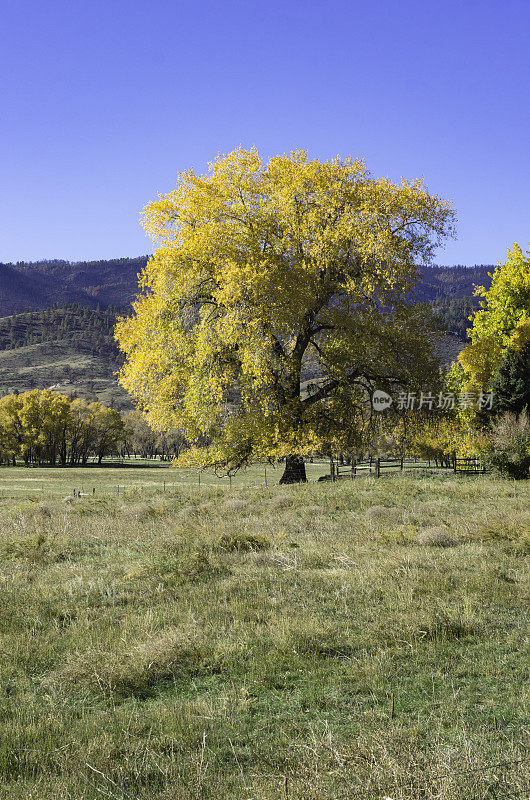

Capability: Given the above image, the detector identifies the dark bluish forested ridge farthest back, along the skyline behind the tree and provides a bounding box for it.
[0,256,494,316]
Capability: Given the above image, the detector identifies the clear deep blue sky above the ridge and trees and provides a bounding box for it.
[0,0,530,264]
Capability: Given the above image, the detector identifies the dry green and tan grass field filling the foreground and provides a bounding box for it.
[0,470,530,800]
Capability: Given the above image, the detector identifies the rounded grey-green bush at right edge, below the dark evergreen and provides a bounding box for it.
[484,412,530,478]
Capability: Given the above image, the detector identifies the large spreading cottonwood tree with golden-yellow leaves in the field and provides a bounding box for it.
[116,149,454,480]
